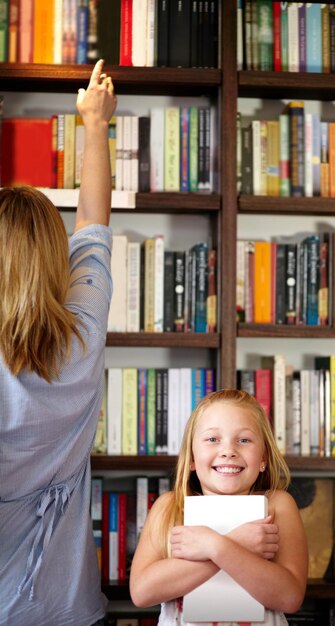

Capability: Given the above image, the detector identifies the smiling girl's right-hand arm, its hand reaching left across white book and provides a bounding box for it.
[172,491,308,613]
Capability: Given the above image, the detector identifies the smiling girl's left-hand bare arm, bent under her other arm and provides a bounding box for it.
[130,492,219,607]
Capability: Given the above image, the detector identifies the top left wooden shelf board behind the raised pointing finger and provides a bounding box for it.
[0,63,222,95]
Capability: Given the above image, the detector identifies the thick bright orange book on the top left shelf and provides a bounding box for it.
[33,0,54,63]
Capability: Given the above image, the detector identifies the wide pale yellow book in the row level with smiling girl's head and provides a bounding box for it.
[122,367,138,455]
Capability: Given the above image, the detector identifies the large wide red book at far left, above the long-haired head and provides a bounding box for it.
[1,118,52,187]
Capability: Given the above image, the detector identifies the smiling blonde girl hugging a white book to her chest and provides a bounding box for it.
[130,389,308,626]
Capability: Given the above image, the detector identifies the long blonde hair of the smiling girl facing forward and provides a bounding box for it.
[160,389,290,556]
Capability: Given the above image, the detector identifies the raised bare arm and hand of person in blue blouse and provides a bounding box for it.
[75,59,116,230]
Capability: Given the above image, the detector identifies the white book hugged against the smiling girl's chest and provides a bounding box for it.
[183,495,268,622]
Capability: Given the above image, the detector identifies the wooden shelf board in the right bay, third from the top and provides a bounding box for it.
[237,323,335,339]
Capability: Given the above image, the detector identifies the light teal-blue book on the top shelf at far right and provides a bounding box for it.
[306,2,322,72]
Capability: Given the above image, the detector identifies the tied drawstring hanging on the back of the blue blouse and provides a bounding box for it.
[18,483,70,600]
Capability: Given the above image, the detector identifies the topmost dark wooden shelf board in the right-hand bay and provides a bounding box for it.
[237,70,334,100]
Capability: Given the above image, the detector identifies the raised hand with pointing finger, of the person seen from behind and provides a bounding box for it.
[77,59,117,124]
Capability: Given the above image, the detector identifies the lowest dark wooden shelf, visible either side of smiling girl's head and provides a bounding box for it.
[91,454,335,472]
